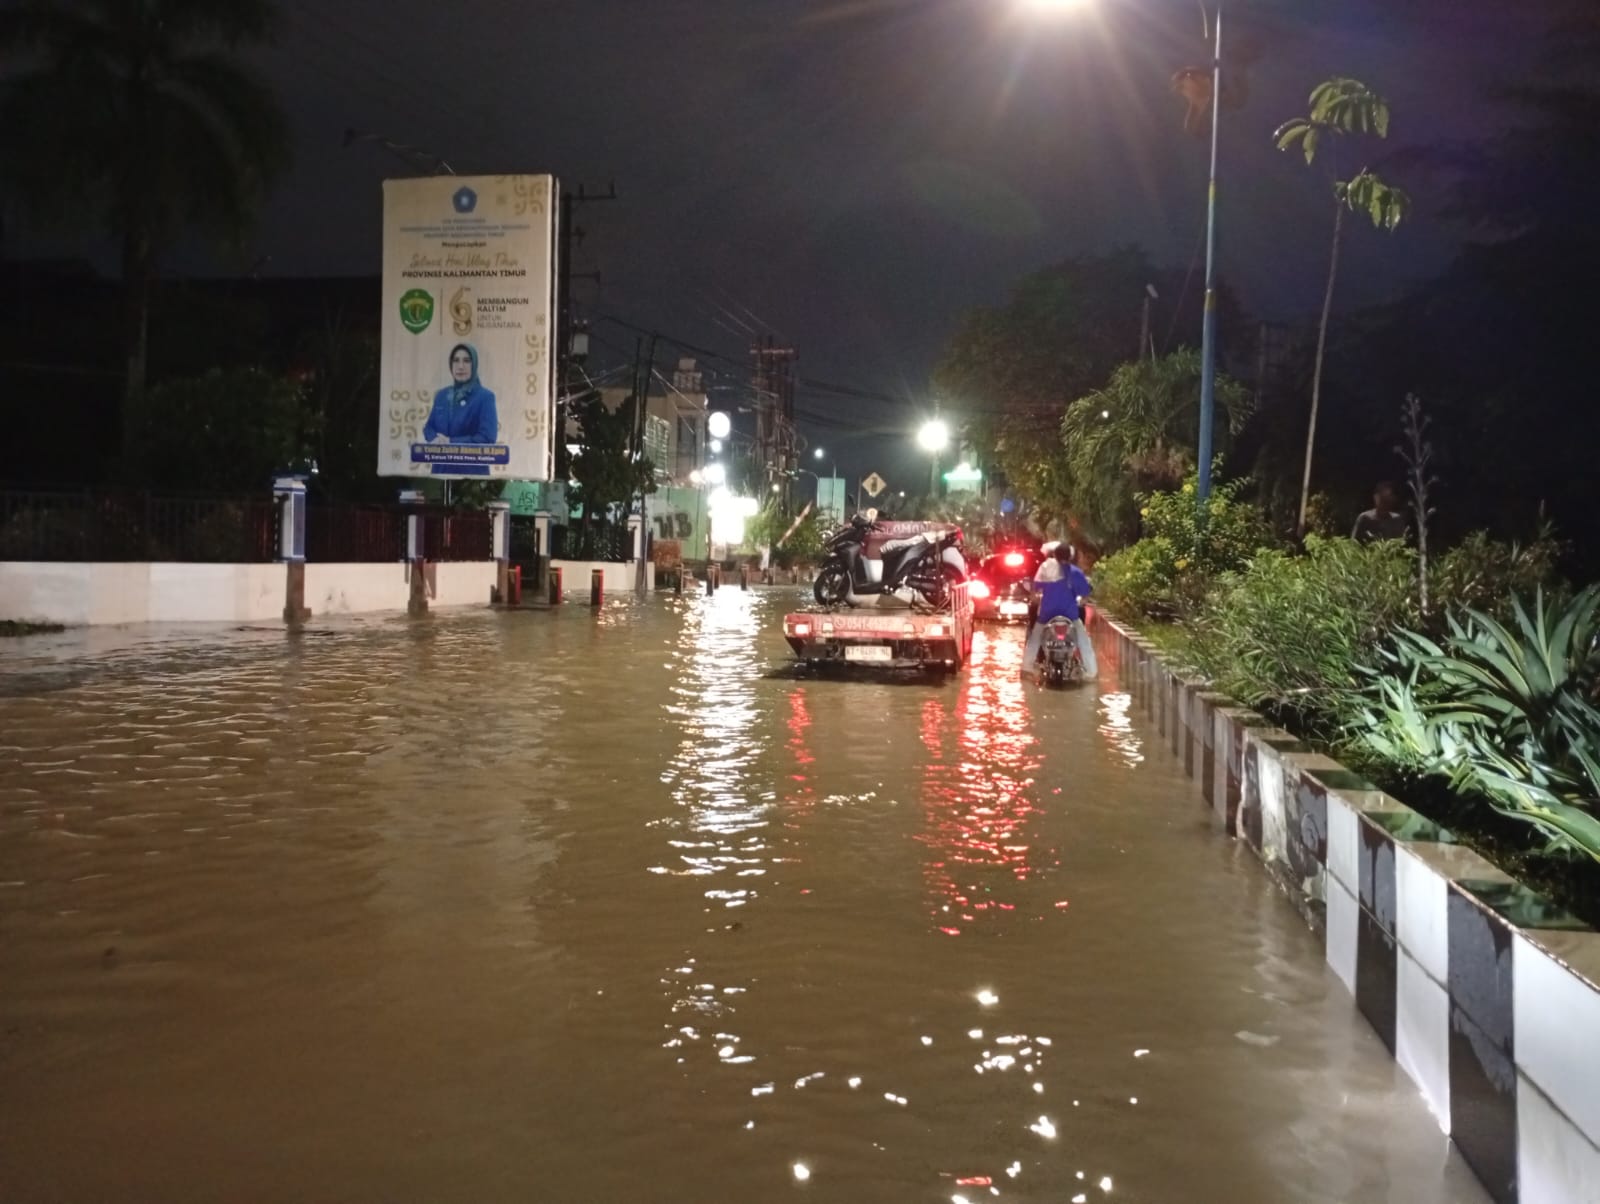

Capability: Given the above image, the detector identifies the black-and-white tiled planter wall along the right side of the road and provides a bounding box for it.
[1094,615,1600,1204]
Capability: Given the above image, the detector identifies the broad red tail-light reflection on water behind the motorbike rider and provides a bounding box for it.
[918,631,1040,937]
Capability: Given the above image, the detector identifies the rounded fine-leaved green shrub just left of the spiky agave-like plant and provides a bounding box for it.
[1194,535,1418,740]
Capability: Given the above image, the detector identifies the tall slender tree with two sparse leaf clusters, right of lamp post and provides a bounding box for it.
[1272,77,1411,535]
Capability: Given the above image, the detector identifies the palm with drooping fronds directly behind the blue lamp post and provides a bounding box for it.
[1061,347,1253,544]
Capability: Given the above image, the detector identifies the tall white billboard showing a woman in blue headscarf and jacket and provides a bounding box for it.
[378,176,557,480]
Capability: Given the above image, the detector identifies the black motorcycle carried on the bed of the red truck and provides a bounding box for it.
[811,511,966,610]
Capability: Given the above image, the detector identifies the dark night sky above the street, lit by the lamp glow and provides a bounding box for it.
[190,0,1541,480]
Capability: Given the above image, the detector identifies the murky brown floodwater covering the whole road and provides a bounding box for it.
[0,589,1482,1204]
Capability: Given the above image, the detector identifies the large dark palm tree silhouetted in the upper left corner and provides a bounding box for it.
[0,0,290,447]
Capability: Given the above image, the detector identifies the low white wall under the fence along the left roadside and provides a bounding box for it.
[0,560,499,628]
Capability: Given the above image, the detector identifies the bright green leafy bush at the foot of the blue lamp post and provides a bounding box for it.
[1094,477,1270,620]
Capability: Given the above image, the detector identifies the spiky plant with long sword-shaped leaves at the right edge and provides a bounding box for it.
[1350,586,1600,861]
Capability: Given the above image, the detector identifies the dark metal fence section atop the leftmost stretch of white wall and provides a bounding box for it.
[0,490,278,564]
